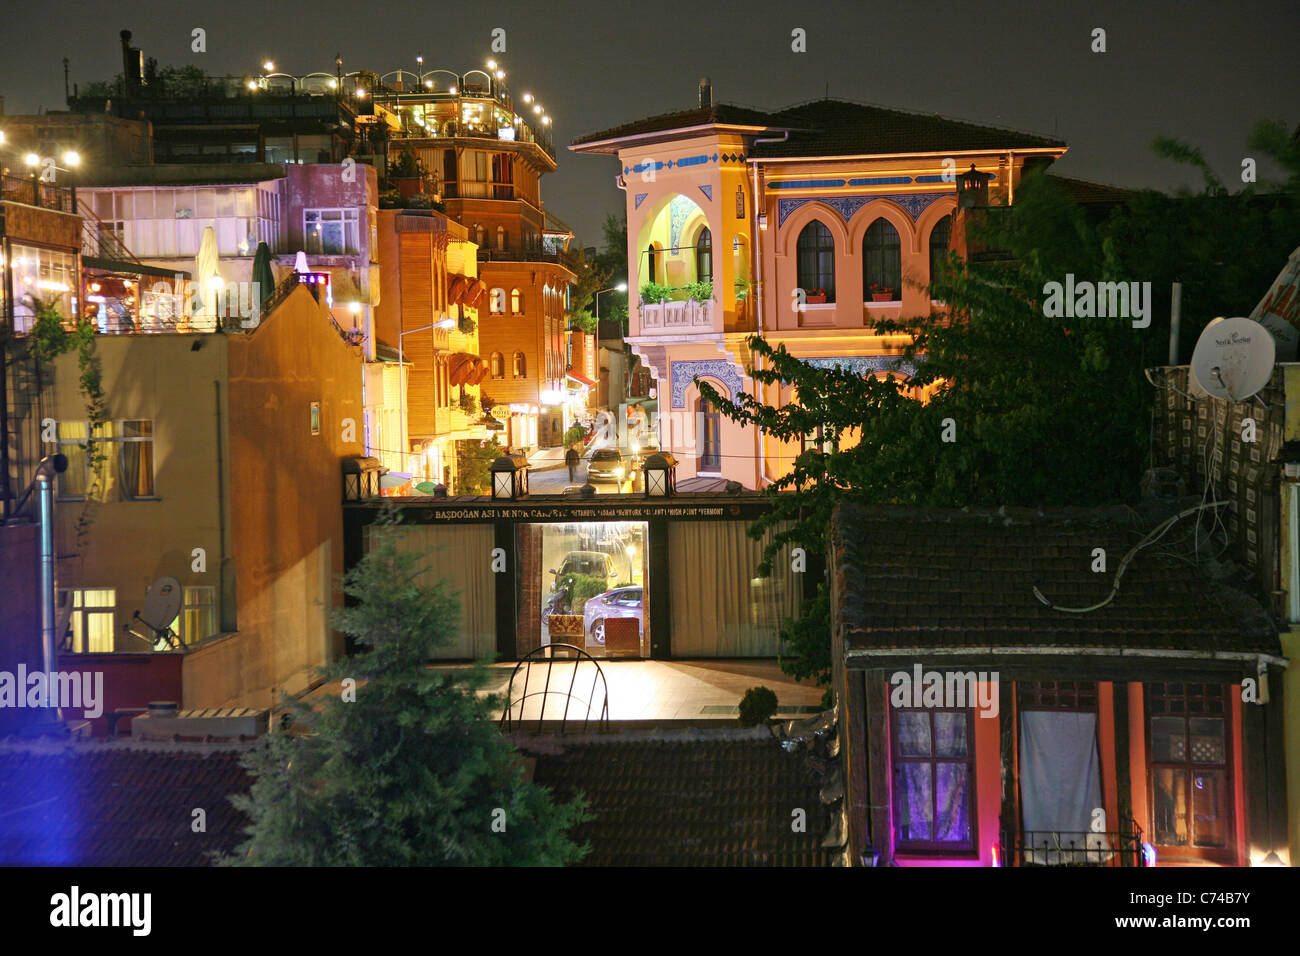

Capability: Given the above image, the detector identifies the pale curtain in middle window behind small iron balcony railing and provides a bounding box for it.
[1021,710,1110,865]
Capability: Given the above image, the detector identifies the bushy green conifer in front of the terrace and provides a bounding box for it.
[220,512,585,866]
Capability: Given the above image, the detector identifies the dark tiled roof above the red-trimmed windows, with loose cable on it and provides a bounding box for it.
[832,505,1281,656]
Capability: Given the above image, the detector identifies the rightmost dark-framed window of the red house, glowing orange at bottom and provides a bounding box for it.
[1143,680,1236,864]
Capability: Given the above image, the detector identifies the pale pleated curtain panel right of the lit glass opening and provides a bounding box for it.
[668,522,800,657]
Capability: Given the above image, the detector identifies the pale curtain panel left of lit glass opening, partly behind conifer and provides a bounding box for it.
[379,524,497,661]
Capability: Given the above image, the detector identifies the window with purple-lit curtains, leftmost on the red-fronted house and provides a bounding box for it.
[889,708,975,853]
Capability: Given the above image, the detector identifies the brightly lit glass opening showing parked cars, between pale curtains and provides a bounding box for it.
[516,522,650,657]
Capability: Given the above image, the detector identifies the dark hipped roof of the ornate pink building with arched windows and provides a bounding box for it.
[572,99,1065,157]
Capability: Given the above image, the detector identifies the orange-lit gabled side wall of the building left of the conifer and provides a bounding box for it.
[195,287,363,708]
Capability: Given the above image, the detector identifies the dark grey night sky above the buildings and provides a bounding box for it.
[0,0,1300,245]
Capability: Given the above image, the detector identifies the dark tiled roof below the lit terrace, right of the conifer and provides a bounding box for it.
[525,731,829,866]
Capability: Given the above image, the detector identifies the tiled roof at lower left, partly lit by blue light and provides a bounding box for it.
[0,741,250,866]
